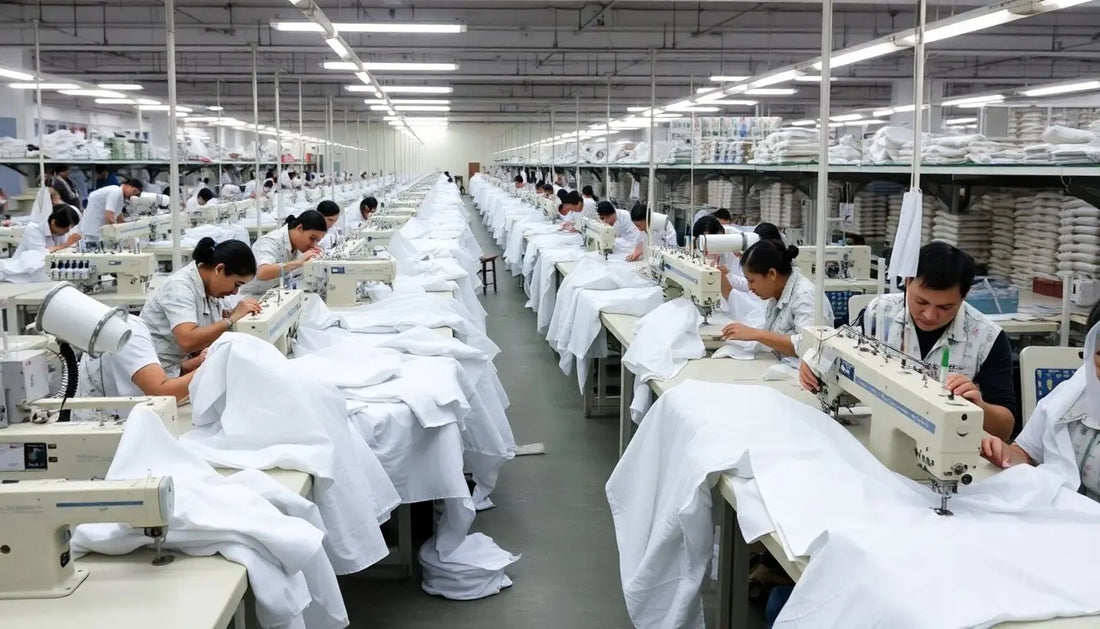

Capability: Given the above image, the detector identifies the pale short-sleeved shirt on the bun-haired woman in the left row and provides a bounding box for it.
[141,262,224,377]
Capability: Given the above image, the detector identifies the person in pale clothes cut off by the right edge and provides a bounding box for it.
[981,325,1100,500]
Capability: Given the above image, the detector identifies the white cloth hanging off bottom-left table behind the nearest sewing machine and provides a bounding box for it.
[72,407,348,629]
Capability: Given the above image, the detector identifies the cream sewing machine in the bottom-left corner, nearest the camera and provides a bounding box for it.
[0,476,175,599]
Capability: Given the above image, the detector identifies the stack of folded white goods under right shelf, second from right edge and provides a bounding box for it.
[1012,191,1064,289]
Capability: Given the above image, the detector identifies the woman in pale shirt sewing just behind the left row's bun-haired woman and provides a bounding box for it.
[241,210,329,295]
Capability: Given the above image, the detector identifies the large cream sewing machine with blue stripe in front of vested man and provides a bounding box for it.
[800,327,985,515]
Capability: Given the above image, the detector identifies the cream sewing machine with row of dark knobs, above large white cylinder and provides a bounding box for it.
[45,250,156,296]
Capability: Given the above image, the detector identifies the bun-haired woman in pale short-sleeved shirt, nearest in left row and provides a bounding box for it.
[141,236,260,377]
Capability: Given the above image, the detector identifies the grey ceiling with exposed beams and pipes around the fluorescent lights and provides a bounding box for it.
[0,0,1100,125]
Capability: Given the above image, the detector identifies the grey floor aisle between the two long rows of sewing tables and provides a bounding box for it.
[341,201,630,629]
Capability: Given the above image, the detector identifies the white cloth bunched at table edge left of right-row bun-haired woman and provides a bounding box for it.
[623,297,706,423]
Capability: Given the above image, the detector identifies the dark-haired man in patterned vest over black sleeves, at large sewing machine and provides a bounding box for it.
[799,242,1016,440]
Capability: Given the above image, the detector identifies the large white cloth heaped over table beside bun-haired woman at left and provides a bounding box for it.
[184,333,399,574]
